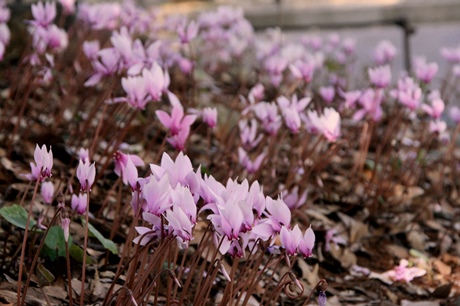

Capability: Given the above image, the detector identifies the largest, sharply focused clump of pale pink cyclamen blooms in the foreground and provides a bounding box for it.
[115,152,315,257]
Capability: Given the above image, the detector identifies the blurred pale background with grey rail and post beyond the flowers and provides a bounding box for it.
[157,0,460,76]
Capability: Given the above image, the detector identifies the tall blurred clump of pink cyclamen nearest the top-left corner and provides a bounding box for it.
[28,2,68,83]
